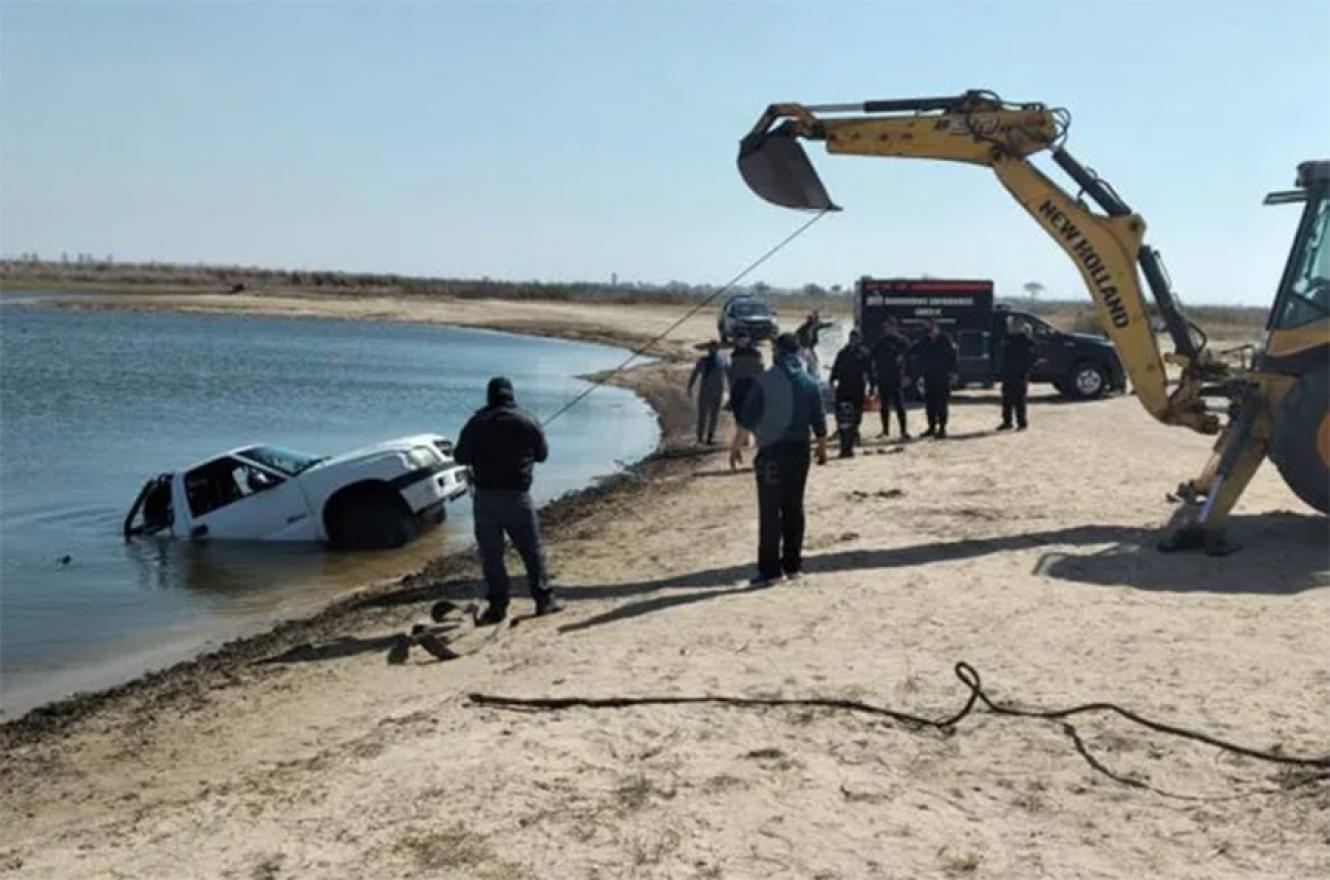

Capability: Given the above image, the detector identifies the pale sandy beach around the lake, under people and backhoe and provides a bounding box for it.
[0,295,1330,880]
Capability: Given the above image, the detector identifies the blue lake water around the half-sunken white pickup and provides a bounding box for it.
[0,295,658,718]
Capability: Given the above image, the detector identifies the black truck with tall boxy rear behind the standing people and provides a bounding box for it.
[854,278,1127,400]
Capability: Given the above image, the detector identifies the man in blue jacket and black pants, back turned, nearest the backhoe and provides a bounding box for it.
[730,334,827,586]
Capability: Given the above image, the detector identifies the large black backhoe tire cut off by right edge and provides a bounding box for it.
[1270,367,1330,513]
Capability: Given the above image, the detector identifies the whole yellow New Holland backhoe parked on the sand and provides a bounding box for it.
[738,92,1330,554]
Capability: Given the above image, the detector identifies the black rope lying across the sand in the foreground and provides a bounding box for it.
[468,662,1330,800]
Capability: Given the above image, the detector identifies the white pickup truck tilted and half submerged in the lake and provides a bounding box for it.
[124,433,468,549]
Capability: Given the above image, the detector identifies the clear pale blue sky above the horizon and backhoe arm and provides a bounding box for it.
[0,0,1330,303]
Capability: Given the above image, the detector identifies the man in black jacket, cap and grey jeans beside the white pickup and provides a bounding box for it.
[452,376,564,625]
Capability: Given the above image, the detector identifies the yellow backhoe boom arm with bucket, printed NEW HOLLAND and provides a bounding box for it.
[739,92,1222,433]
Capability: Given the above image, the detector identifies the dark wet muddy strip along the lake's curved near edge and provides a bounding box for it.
[0,309,693,748]
